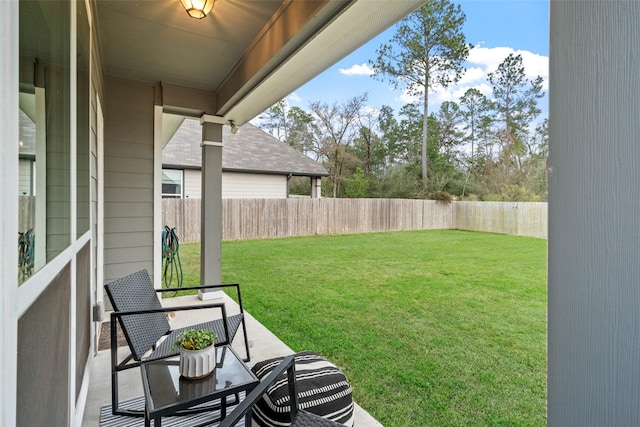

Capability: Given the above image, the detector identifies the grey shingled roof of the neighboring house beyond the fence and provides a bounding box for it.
[162,119,329,176]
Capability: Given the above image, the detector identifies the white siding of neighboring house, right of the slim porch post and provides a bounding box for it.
[222,172,287,199]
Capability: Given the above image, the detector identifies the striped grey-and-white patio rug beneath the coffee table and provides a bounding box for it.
[100,396,244,427]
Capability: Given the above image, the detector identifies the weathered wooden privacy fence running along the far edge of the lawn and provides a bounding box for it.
[162,198,547,243]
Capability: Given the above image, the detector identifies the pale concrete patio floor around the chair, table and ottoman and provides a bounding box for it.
[82,294,382,427]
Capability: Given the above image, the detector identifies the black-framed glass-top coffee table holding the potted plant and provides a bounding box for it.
[140,345,260,427]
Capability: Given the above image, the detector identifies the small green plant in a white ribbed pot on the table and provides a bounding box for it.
[174,329,216,378]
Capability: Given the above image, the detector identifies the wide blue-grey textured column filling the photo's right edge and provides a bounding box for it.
[547,0,640,427]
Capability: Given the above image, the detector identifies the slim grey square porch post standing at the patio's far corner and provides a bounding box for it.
[199,116,222,300]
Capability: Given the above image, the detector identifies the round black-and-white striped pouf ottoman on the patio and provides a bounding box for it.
[251,351,353,427]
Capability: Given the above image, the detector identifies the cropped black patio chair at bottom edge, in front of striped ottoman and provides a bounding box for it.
[219,355,344,427]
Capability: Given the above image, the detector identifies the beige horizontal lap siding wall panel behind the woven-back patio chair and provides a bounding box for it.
[104,78,154,282]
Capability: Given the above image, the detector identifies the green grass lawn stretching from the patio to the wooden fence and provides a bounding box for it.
[180,230,547,427]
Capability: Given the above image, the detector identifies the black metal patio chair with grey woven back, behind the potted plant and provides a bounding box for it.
[105,270,250,416]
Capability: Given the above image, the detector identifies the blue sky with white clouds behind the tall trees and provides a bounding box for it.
[272,0,549,120]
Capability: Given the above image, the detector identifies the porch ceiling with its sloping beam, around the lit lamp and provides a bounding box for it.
[96,0,424,124]
